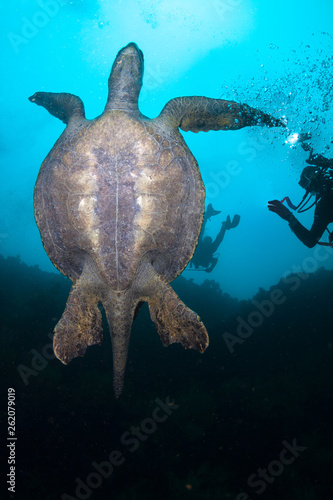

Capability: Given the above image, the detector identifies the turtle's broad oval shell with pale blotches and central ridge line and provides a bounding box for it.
[36,111,204,290]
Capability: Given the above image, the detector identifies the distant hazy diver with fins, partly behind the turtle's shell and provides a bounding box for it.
[190,203,240,273]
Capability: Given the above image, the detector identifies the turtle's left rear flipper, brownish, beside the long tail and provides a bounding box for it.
[53,279,103,365]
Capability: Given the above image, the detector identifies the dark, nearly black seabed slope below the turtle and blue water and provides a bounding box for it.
[0,257,333,500]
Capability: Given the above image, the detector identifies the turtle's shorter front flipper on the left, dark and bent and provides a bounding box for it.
[29,92,85,125]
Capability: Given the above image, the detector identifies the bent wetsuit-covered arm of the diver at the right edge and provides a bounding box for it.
[289,194,333,248]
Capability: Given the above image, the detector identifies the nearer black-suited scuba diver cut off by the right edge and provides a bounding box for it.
[268,134,333,248]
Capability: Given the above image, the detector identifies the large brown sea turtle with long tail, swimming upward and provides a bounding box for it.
[29,43,283,397]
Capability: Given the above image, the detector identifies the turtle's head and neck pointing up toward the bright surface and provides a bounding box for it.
[105,42,143,111]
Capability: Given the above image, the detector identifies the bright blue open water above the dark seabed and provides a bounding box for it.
[0,0,333,298]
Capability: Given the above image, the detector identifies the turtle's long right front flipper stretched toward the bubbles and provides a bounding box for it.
[156,96,286,132]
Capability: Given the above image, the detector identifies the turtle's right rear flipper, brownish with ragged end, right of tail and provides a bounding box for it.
[148,280,209,352]
